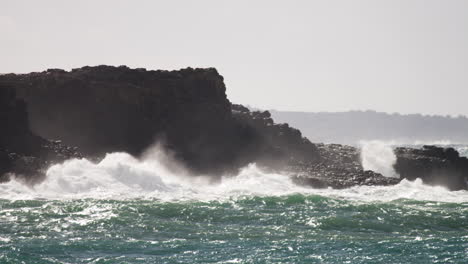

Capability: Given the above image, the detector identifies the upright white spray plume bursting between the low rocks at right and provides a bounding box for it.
[360,140,399,178]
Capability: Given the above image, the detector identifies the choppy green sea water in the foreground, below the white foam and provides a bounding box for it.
[0,194,468,263]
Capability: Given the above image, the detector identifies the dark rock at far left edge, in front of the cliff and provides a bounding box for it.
[0,85,80,182]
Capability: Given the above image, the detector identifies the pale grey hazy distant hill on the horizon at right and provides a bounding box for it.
[270,110,468,144]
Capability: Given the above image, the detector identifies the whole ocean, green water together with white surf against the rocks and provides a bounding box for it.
[0,145,468,264]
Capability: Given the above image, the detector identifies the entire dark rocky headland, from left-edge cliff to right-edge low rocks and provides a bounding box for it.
[0,66,468,190]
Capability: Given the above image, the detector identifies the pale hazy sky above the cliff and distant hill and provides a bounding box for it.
[0,0,468,115]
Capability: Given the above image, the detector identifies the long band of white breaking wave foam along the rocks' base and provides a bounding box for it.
[0,150,468,203]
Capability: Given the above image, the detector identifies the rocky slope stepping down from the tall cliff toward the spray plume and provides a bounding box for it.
[232,105,400,189]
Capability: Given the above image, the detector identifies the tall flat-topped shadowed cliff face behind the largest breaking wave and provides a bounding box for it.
[0,66,320,175]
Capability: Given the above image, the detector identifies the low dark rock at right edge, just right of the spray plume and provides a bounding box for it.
[394,146,468,190]
